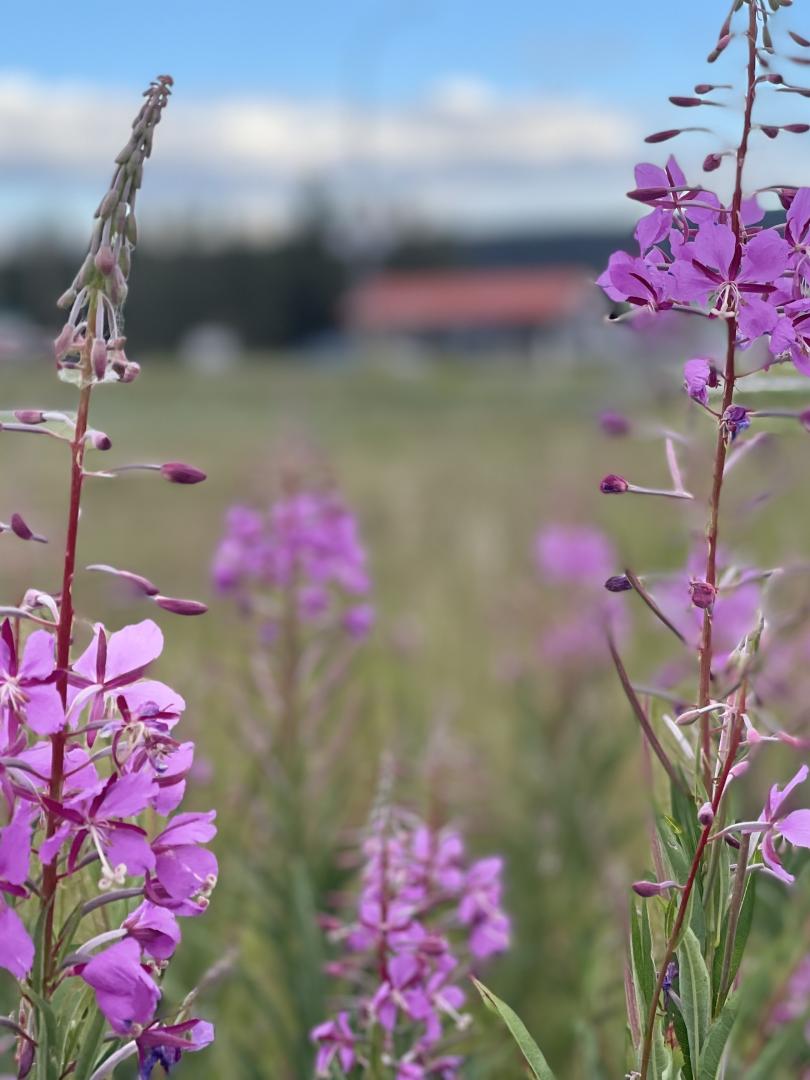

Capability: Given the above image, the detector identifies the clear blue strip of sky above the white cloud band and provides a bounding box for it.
[3,0,726,103]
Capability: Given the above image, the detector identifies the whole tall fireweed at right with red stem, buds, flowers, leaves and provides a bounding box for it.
[475,0,810,1080]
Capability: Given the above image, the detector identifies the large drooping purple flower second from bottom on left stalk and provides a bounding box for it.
[77,937,160,1035]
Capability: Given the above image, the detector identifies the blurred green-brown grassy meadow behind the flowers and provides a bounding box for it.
[0,357,810,1080]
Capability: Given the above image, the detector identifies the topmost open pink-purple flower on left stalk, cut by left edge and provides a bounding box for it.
[0,619,65,735]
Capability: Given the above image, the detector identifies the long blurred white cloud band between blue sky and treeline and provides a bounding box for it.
[0,73,638,243]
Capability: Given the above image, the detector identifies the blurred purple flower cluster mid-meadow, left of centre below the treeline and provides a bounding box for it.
[213,491,374,640]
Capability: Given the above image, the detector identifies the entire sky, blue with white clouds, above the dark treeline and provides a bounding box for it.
[0,0,810,247]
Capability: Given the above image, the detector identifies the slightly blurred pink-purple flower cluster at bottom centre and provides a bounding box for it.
[312,810,510,1080]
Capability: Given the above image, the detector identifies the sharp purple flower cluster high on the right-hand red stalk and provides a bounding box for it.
[598,157,810,371]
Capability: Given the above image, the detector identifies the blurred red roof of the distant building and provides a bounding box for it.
[343,267,593,333]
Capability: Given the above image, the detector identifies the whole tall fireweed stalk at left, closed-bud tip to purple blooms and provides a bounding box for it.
[0,76,217,1080]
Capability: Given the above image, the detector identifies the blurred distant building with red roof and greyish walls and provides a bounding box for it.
[342,266,594,357]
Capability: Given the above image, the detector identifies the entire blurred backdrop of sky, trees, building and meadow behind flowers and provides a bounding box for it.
[0,0,810,1080]
